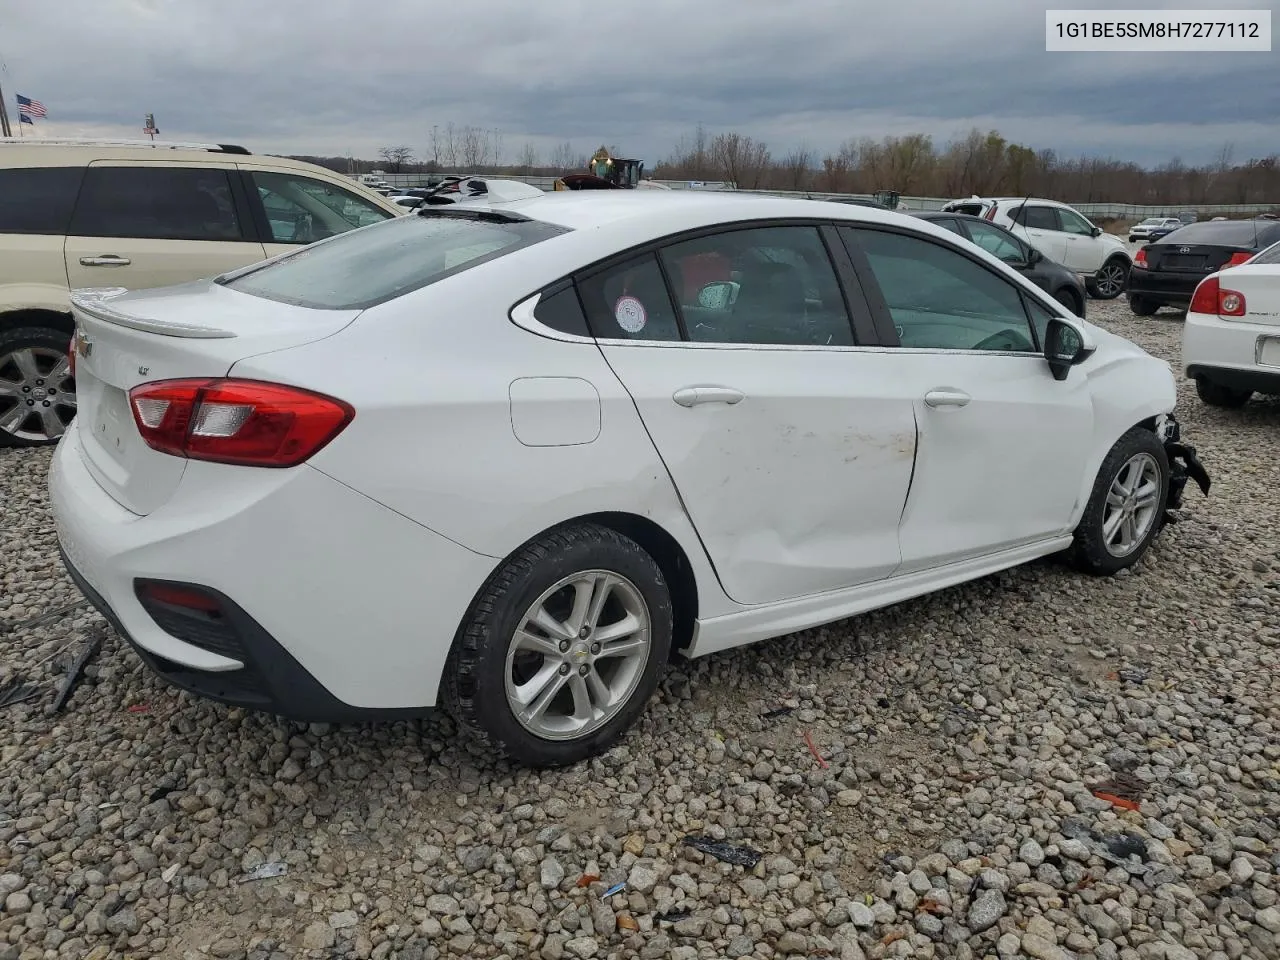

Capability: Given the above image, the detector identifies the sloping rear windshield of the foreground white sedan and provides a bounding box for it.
[220,211,568,310]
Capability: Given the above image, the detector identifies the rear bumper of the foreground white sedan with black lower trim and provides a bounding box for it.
[49,421,494,721]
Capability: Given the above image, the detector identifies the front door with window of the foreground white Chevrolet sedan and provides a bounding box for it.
[847,228,1093,573]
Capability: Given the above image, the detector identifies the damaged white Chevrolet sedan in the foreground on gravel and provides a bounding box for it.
[49,191,1208,765]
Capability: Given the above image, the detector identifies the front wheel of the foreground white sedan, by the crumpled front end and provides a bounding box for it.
[1070,426,1170,576]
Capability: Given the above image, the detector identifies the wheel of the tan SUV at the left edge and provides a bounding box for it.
[0,326,76,447]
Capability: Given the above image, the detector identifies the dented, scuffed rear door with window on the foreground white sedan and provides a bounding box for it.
[579,225,915,604]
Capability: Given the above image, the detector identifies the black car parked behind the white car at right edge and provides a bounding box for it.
[1128,220,1280,316]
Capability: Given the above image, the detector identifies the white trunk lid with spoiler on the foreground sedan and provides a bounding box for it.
[72,280,360,515]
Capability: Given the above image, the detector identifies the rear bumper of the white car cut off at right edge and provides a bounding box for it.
[1183,314,1280,393]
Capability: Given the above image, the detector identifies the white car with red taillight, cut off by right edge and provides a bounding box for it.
[1183,243,1280,407]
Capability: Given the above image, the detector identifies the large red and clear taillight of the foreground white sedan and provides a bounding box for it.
[129,379,356,467]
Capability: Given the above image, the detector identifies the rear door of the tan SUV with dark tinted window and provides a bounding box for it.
[64,160,266,289]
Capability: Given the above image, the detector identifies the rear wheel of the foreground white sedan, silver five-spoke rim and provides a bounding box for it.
[442,524,673,768]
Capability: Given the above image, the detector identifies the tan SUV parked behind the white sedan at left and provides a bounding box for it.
[0,138,407,447]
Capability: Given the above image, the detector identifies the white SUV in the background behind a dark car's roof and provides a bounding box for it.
[942,197,1133,300]
